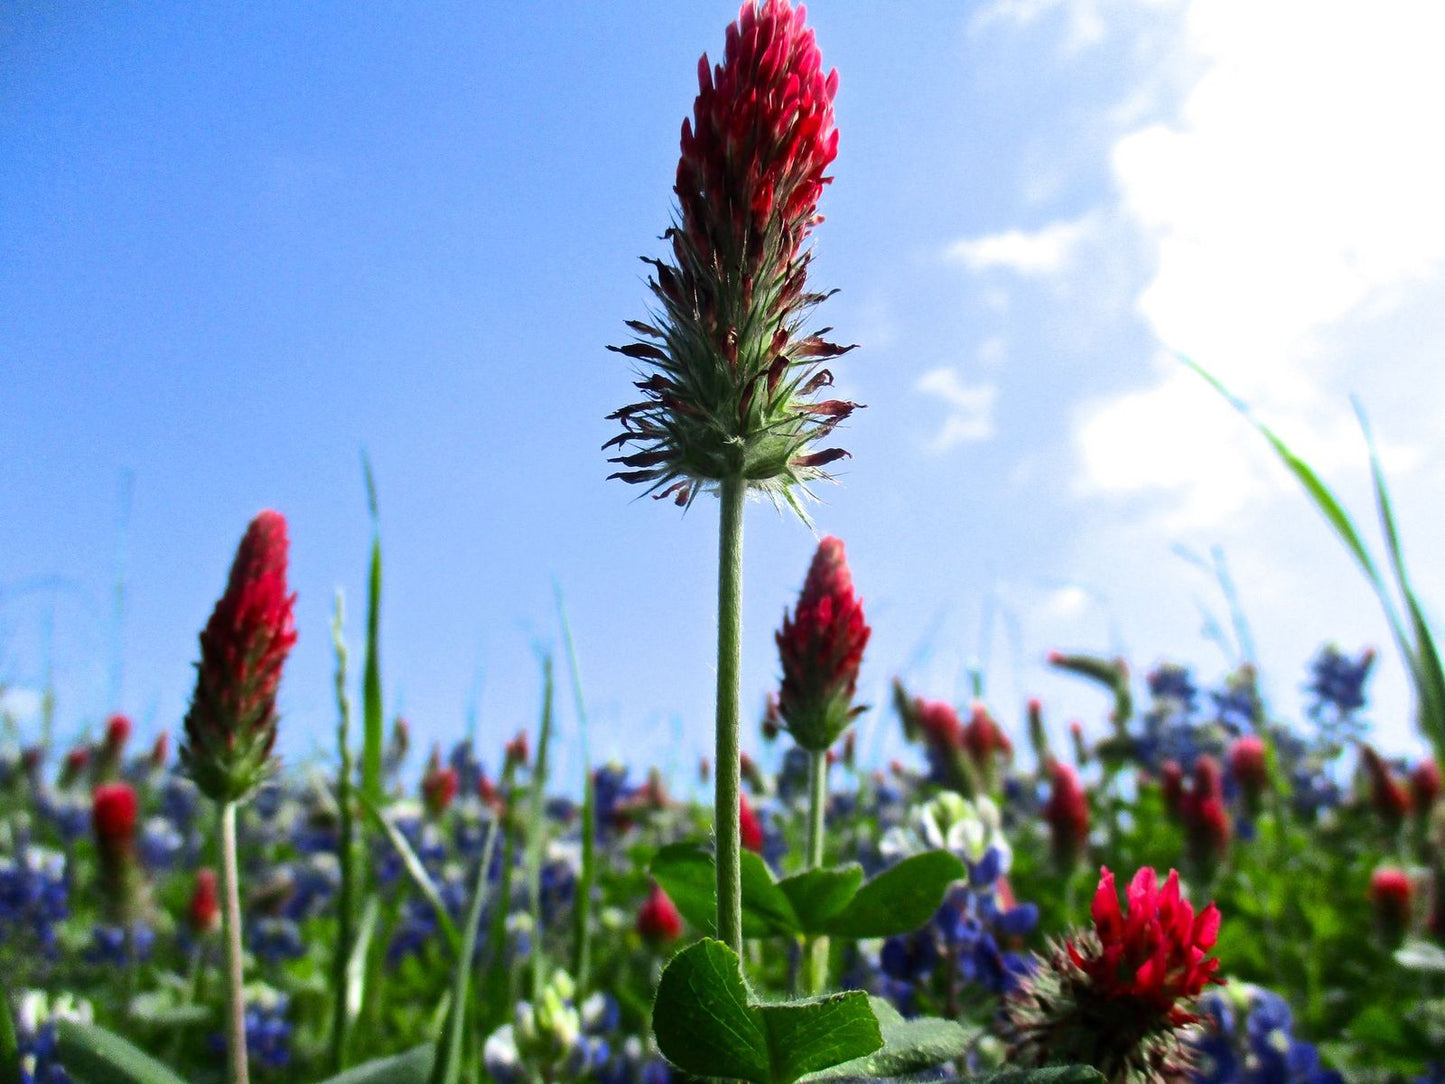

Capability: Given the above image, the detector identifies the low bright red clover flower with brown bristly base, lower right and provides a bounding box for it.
[1003,867,1224,1084]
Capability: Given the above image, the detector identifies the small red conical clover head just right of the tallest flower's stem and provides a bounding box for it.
[775,535,873,752]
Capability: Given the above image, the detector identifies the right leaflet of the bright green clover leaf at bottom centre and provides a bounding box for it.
[759,990,883,1084]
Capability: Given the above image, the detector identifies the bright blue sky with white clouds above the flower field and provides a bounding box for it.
[0,0,1445,772]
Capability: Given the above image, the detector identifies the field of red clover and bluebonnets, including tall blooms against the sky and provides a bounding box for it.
[0,0,1445,1084]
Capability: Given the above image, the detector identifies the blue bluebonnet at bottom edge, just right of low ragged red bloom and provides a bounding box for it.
[1192,983,1341,1084]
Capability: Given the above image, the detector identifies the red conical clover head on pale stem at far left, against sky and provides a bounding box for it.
[181,512,296,802]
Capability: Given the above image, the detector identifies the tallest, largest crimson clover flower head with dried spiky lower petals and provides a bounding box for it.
[603,0,857,513]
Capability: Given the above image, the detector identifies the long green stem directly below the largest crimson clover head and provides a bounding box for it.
[712,474,747,957]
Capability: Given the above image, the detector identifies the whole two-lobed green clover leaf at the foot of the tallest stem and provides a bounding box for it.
[652,939,883,1084]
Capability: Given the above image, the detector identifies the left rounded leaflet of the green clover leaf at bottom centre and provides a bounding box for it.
[652,939,772,1084]
